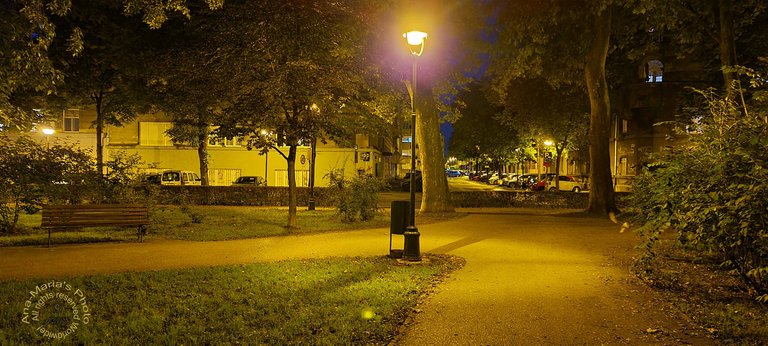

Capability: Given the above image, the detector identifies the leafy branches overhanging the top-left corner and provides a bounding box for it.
[0,0,224,129]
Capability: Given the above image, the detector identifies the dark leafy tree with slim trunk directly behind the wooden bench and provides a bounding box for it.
[49,1,152,175]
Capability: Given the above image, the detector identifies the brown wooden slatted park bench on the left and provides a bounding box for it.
[41,204,149,247]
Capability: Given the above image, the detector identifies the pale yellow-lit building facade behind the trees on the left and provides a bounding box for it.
[32,108,400,186]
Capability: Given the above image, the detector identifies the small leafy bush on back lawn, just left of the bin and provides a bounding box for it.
[330,174,386,222]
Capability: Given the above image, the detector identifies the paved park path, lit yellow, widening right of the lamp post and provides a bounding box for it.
[0,210,708,345]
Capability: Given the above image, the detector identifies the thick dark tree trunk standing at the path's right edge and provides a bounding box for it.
[584,7,617,215]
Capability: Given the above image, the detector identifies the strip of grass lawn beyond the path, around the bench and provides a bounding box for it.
[0,206,464,246]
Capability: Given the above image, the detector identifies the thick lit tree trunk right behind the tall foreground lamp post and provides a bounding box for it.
[416,98,454,213]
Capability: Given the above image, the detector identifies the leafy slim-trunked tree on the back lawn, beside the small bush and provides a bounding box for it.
[194,0,390,227]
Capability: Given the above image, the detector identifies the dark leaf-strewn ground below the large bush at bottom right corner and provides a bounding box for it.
[645,242,768,345]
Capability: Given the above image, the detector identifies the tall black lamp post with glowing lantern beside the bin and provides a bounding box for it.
[403,31,427,261]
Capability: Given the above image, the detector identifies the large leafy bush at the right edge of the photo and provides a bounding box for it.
[630,74,768,301]
